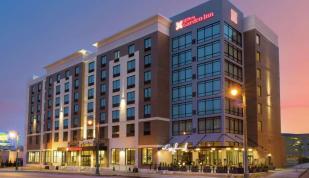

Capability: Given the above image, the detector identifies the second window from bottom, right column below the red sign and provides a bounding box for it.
[197,98,221,115]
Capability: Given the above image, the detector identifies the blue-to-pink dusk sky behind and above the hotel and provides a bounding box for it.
[0,0,309,142]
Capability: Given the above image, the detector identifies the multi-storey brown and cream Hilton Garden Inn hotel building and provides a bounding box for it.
[25,0,284,170]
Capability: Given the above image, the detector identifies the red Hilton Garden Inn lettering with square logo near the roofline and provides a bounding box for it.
[176,12,215,30]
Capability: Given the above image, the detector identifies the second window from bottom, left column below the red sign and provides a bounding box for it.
[172,102,192,119]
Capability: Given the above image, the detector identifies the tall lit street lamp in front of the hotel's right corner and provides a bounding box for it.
[229,87,249,178]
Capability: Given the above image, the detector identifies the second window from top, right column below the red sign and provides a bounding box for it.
[197,41,220,61]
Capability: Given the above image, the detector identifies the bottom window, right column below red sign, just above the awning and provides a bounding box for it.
[198,117,221,134]
